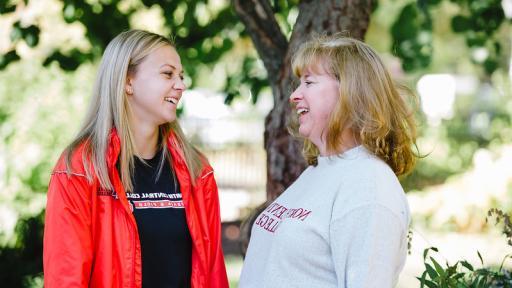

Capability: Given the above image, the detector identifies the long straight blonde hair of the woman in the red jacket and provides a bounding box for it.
[65,30,205,191]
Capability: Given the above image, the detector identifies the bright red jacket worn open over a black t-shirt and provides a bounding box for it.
[43,131,229,288]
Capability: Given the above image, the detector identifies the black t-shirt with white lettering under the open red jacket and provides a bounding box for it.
[127,150,192,288]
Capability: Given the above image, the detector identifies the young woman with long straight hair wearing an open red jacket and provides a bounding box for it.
[44,30,228,288]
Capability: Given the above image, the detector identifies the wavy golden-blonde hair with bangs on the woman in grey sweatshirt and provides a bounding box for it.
[291,34,418,175]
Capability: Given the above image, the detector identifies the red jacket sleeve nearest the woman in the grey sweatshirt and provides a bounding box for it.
[205,171,229,288]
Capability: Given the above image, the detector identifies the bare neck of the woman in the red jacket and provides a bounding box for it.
[131,125,158,159]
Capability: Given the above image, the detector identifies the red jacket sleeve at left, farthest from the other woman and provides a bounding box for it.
[43,172,93,288]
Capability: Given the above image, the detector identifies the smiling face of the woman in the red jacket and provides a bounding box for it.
[126,45,186,128]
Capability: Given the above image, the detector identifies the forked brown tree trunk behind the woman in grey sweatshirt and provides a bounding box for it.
[234,0,372,202]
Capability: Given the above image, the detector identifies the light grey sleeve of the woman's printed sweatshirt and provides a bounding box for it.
[330,204,406,288]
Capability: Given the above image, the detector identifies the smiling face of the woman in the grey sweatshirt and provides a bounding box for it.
[290,65,339,154]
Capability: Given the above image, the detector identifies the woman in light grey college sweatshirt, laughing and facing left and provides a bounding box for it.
[239,36,415,288]
